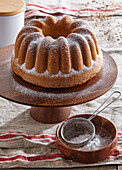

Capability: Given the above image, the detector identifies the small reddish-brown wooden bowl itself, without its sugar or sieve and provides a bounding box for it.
[56,114,117,163]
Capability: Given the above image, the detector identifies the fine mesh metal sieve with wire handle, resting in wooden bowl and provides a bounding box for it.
[61,91,121,147]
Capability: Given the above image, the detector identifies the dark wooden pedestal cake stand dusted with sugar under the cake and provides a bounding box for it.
[0,45,117,123]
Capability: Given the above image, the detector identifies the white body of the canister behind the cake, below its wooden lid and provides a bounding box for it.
[0,11,24,48]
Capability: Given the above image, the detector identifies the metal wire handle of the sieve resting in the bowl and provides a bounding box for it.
[88,91,121,120]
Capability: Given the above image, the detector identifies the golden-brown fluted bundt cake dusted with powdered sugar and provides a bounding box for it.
[11,16,103,88]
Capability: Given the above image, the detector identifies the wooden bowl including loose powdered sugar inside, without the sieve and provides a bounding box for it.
[56,114,117,163]
